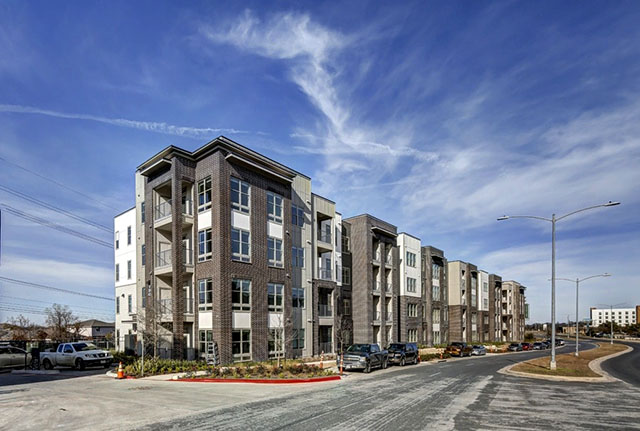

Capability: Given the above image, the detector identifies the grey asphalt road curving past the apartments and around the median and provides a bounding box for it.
[139,342,640,431]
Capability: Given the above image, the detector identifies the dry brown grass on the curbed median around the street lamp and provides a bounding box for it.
[512,343,627,377]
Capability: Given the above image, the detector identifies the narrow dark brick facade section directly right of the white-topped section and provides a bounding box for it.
[421,246,449,346]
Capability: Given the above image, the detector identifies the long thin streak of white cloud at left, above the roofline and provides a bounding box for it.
[0,104,252,139]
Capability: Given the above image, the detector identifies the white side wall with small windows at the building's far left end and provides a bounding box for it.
[113,208,138,351]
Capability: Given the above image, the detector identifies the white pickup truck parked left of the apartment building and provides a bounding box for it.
[40,341,113,370]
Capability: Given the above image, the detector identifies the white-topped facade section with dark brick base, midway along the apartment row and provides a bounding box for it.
[397,232,426,343]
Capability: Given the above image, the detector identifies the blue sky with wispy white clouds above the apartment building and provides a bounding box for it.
[0,1,640,321]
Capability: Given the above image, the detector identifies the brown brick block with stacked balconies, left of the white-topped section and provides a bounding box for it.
[343,214,399,346]
